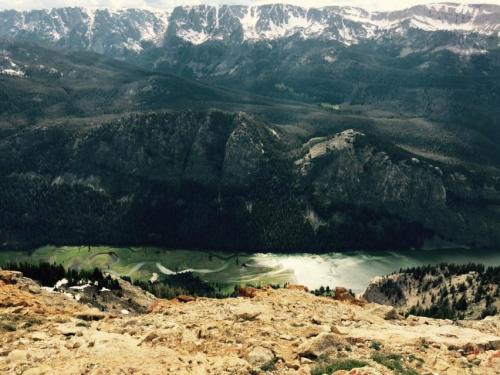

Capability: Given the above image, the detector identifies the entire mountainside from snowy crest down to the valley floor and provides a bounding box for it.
[0,3,500,251]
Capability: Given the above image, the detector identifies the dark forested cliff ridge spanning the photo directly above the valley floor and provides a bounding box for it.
[0,111,500,251]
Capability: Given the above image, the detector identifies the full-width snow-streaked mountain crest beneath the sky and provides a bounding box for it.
[0,3,500,54]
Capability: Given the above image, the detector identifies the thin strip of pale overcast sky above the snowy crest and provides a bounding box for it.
[0,0,500,9]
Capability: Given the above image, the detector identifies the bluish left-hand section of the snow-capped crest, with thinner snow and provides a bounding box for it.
[0,8,168,53]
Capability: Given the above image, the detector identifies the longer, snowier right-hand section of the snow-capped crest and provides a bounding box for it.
[169,4,500,44]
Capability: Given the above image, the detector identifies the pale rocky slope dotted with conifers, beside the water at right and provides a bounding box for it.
[363,264,500,319]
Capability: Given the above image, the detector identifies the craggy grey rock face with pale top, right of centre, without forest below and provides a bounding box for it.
[301,130,446,223]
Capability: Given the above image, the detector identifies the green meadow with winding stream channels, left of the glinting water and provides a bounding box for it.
[0,246,293,287]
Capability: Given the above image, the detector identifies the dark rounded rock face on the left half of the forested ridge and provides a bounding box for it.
[71,111,235,185]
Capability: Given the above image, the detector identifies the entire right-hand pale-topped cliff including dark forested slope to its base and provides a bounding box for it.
[296,130,499,247]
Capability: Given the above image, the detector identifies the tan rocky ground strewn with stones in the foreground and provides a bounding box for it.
[0,271,500,375]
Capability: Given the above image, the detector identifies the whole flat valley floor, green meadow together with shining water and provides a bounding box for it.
[0,246,500,293]
